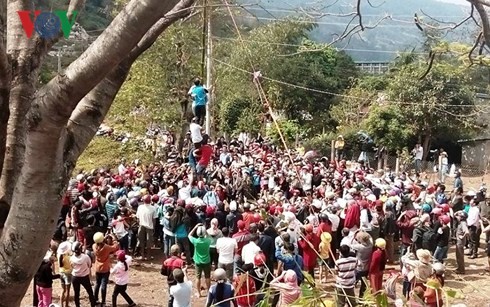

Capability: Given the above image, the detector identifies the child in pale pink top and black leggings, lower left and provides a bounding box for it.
[111,250,136,307]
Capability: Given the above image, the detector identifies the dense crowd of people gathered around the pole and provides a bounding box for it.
[35,118,490,307]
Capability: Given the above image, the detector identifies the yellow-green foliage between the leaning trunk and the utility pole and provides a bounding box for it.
[108,23,200,134]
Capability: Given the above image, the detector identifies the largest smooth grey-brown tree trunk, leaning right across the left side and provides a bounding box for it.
[0,0,189,307]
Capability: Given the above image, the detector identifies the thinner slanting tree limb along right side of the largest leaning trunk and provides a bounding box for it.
[63,0,196,182]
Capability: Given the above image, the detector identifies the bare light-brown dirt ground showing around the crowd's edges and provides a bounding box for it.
[22,176,490,307]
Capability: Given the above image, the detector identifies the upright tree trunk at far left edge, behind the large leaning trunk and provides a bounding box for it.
[0,0,40,223]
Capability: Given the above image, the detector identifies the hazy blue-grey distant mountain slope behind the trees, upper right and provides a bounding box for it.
[239,0,474,61]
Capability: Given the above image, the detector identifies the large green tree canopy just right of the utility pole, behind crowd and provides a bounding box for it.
[215,20,357,133]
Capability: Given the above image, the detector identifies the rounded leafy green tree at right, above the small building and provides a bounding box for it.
[387,57,474,142]
